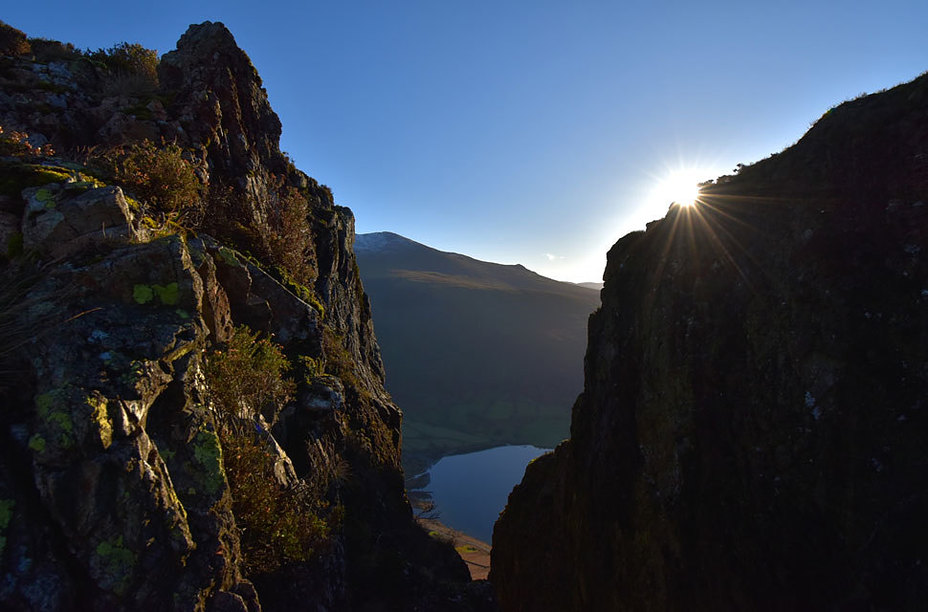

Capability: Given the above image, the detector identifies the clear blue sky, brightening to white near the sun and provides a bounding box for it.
[0,0,928,282]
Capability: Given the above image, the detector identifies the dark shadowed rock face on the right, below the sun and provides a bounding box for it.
[491,71,928,611]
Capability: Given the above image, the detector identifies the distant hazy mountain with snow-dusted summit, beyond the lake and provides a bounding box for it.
[355,232,599,470]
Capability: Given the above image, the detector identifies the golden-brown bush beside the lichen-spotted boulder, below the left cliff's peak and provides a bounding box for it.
[92,140,203,227]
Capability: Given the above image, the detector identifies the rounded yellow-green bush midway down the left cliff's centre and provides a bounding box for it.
[206,326,295,426]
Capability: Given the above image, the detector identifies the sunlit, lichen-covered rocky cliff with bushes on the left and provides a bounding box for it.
[0,22,486,611]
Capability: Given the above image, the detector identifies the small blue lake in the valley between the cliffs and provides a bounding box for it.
[425,446,551,542]
